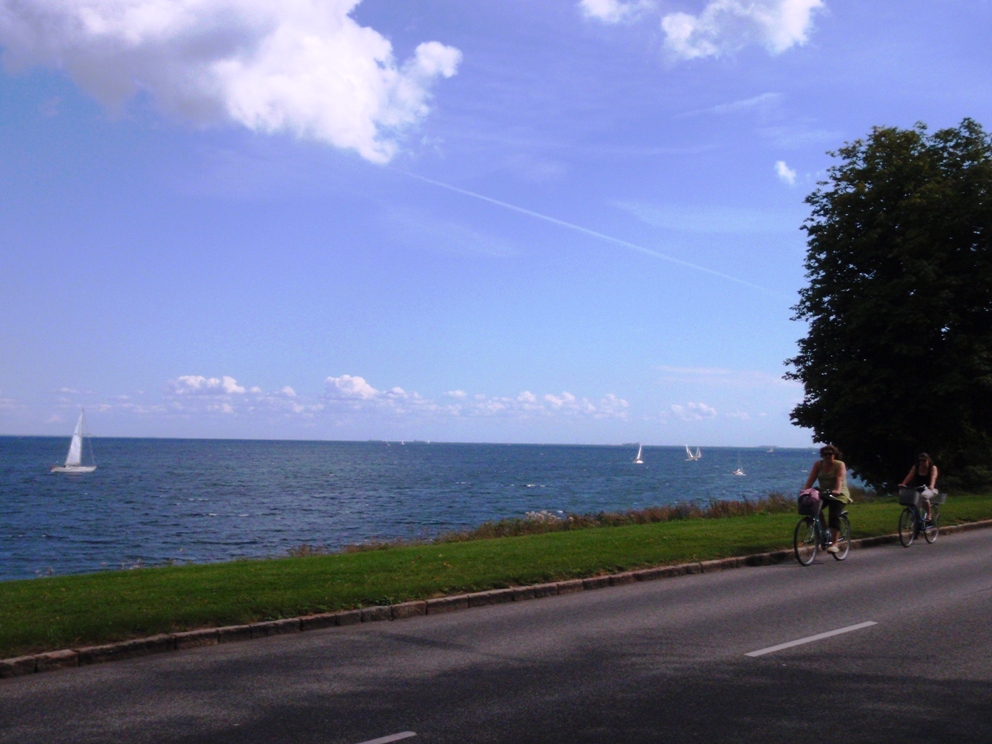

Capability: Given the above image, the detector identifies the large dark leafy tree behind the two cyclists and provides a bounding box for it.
[788,119,992,487]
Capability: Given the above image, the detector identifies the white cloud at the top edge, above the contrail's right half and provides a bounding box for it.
[661,0,824,59]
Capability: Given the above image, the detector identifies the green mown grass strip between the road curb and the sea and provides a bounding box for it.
[0,494,992,658]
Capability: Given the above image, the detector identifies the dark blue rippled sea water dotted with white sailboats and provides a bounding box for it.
[0,437,816,580]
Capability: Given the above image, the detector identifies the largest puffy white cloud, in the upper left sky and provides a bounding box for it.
[0,0,461,163]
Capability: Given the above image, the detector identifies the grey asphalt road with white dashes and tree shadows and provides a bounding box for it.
[0,530,992,744]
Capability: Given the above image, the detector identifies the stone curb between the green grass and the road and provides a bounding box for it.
[0,519,992,679]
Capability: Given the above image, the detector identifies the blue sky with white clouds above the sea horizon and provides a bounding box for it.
[0,0,992,446]
